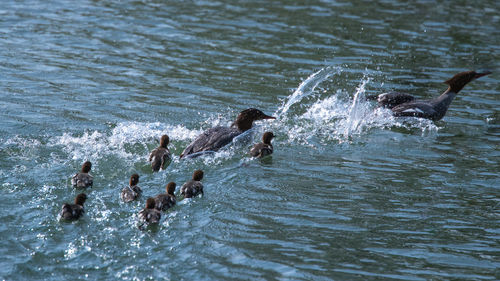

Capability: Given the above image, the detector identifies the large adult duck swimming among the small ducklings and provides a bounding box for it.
[180,108,276,158]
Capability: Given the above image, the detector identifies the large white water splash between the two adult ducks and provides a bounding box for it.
[277,68,438,147]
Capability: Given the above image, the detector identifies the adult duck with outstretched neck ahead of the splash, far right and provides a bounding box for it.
[368,71,491,121]
